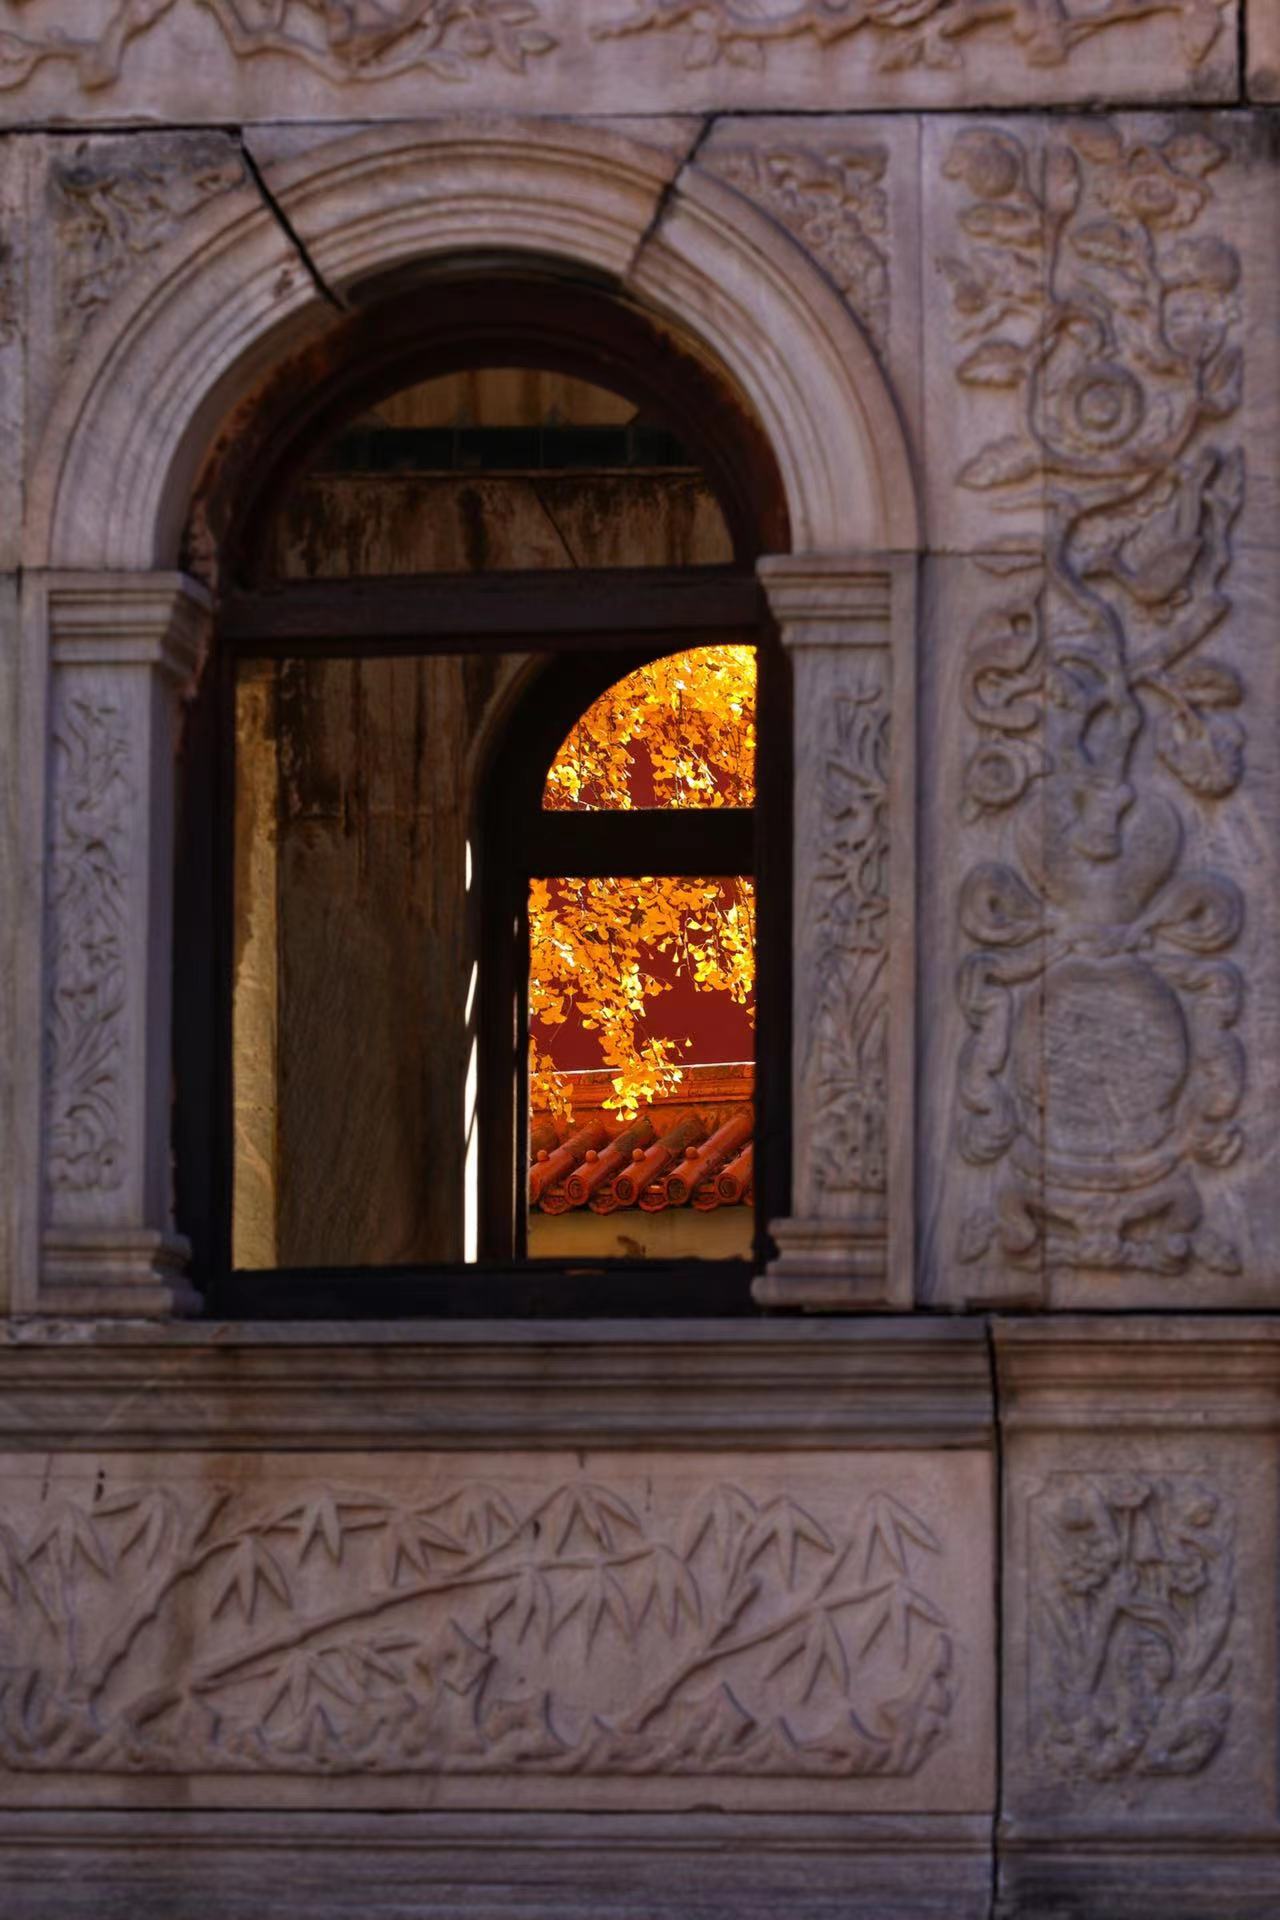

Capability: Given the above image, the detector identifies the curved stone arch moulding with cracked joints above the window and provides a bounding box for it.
[31,121,919,570]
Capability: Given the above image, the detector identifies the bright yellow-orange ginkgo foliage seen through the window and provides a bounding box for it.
[530,647,756,1119]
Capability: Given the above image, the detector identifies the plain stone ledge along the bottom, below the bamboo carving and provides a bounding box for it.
[0,1811,990,1920]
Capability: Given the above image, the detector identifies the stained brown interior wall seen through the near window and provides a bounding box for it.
[232,369,733,1267]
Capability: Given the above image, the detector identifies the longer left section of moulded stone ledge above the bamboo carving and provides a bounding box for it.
[0,1319,992,1452]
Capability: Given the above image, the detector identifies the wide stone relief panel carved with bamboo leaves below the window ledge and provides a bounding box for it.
[0,1453,990,1811]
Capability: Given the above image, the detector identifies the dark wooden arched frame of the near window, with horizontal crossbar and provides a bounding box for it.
[175,274,791,1319]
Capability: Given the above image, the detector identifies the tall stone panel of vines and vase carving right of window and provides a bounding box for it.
[927,117,1274,1306]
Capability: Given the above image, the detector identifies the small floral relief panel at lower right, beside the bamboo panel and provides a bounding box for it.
[1006,1434,1276,1832]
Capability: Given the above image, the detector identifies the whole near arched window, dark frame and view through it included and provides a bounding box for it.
[177,299,789,1315]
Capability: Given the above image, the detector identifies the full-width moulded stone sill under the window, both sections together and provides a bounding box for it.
[0,1313,1280,1452]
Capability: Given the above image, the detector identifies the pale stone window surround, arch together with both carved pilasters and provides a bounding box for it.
[13,123,917,1315]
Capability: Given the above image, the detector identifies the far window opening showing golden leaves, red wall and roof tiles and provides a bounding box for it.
[528,647,756,1258]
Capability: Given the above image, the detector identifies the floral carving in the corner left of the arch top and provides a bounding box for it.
[54,134,244,357]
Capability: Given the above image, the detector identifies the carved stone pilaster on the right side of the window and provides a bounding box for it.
[756,555,892,1309]
